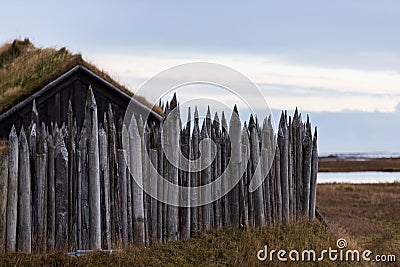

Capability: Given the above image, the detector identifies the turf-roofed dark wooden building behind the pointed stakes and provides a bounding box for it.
[0,39,162,139]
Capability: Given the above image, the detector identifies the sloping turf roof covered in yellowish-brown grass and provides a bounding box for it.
[0,39,162,114]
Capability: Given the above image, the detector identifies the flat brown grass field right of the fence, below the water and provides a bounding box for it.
[317,183,400,260]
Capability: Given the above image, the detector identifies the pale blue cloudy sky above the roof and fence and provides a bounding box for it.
[0,0,400,153]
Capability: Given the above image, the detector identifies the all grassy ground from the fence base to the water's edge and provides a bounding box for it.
[0,184,400,266]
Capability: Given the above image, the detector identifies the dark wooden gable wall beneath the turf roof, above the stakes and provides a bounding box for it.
[0,66,161,139]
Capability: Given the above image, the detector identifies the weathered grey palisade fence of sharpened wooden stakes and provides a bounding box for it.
[0,88,318,253]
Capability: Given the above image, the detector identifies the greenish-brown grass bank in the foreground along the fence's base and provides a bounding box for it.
[0,222,360,266]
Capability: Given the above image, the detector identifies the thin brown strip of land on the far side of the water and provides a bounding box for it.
[318,157,400,172]
